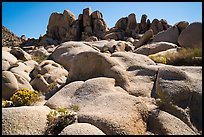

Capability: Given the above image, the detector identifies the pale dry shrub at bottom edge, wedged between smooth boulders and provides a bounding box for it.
[45,108,77,135]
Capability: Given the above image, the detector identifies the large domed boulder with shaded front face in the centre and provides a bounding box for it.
[68,51,128,89]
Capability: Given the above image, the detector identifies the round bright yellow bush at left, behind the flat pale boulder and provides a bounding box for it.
[10,89,39,106]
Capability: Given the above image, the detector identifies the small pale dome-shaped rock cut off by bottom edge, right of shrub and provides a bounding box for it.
[59,123,105,135]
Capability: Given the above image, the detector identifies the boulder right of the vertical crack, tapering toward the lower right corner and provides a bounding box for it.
[156,66,197,132]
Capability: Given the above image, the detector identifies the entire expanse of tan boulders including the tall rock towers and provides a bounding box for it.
[2,8,202,135]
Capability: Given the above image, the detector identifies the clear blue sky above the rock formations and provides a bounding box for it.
[2,2,202,38]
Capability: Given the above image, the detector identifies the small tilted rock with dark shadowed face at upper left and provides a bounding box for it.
[10,47,32,61]
